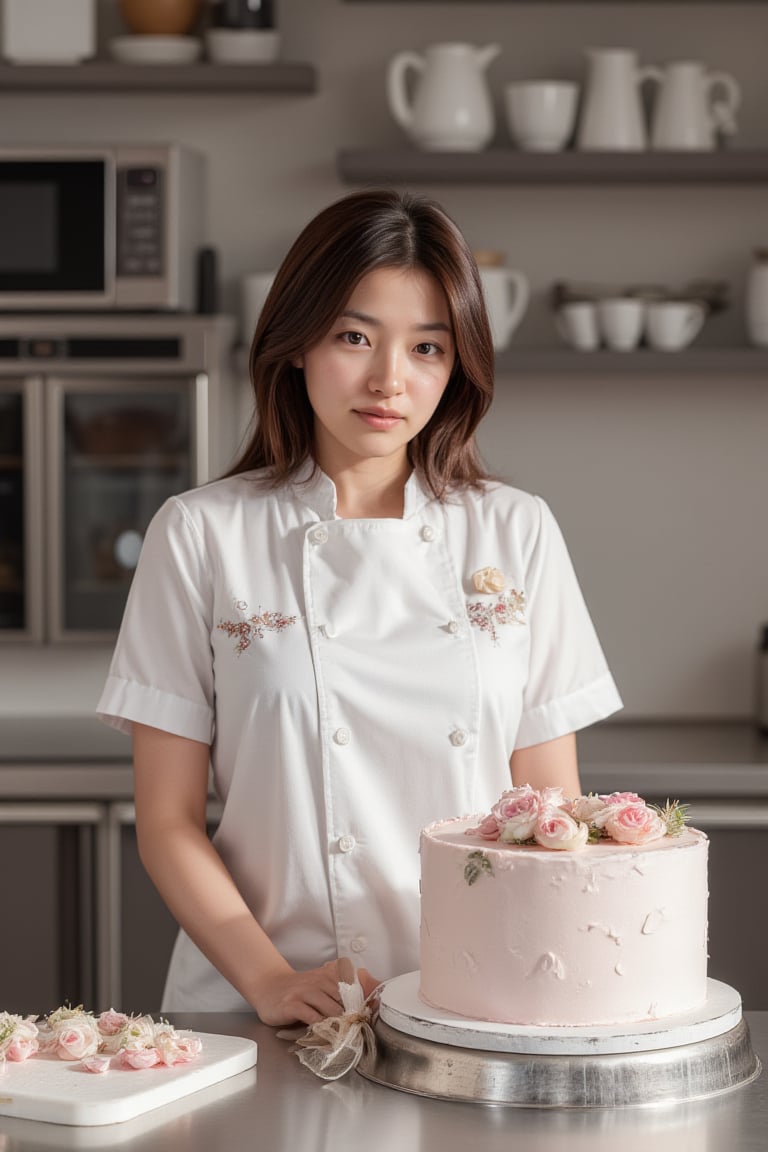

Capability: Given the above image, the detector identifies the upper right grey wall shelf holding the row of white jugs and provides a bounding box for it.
[336,147,768,184]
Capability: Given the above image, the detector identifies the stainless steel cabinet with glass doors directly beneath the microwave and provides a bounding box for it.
[0,317,237,643]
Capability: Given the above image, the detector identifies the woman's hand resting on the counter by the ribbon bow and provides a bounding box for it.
[253,960,379,1025]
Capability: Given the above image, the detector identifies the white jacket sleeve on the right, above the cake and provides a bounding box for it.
[516,497,622,748]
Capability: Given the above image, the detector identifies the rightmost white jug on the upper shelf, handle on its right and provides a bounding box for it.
[651,60,742,151]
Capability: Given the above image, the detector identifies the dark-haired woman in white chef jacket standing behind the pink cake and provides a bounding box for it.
[99,191,621,1024]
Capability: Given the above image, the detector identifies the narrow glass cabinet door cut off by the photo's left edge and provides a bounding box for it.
[0,379,43,639]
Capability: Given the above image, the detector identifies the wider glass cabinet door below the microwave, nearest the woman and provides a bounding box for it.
[48,378,200,641]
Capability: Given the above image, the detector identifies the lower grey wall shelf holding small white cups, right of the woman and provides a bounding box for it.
[496,346,768,378]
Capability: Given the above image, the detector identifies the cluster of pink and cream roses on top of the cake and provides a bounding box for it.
[466,785,689,866]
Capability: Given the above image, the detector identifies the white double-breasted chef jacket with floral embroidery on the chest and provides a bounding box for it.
[98,464,621,1011]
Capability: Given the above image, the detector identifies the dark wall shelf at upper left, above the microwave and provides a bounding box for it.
[0,60,317,96]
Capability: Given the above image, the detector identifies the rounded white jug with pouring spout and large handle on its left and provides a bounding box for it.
[387,44,501,152]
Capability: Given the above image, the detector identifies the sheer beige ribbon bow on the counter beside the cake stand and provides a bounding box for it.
[287,964,379,1079]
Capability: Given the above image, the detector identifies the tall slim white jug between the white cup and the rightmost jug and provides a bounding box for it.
[576,48,661,152]
